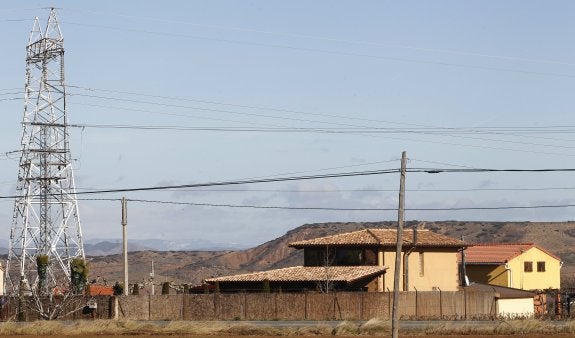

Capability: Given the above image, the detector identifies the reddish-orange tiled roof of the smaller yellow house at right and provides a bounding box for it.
[465,243,560,264]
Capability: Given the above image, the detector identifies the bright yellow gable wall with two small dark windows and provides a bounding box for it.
[507,247,561,290]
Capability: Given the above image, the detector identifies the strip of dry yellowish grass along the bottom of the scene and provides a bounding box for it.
[0,319,575,338]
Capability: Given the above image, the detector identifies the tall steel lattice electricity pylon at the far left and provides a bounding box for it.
[6,9,84,293]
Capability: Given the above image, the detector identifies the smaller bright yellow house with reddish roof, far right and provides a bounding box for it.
[463,243,562,290]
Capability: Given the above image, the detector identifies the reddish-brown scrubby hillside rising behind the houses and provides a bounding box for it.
[90,221,575,290]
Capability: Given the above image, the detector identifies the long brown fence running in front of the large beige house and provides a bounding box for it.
[115,291,496,320]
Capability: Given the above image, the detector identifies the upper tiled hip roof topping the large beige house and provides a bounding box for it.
[289,229,465,248]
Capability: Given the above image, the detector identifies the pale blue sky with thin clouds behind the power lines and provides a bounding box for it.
[0,0,575,246]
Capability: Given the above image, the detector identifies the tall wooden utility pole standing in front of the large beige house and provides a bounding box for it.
[391,151,407,338]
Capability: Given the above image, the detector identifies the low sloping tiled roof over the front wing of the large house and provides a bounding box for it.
[206,266,387,284]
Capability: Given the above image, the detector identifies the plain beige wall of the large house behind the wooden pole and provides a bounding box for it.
[383,248,459,291]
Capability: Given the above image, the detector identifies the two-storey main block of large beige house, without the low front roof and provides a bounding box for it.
[289,229,465,292]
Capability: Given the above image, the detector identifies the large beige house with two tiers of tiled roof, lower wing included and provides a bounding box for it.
[206,229,464,292]
